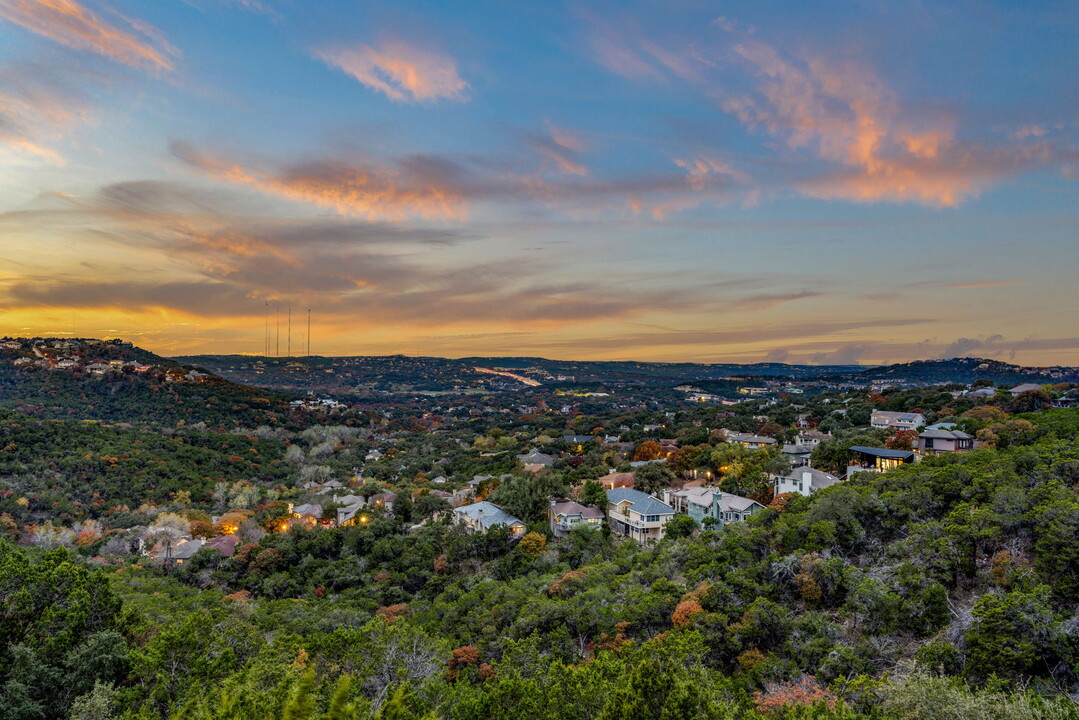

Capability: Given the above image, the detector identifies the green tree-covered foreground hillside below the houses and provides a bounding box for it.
[0,411,1079,720]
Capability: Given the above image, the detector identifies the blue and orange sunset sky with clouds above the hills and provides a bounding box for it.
[0,0,1079,365]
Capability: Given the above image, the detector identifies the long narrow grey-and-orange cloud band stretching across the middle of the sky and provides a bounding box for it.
[170,138,737,221]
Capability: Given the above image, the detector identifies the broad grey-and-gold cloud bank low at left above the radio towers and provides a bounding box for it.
[0,182,712,331]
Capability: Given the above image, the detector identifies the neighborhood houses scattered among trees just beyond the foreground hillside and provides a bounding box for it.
[139,390,1035,565]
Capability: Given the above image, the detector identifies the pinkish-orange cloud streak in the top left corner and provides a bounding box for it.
[0,0,179,72]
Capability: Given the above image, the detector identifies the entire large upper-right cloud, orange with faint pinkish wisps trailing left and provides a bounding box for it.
[587,17,1079,207]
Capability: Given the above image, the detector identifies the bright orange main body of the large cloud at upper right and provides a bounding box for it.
[723,39,1055,206]
